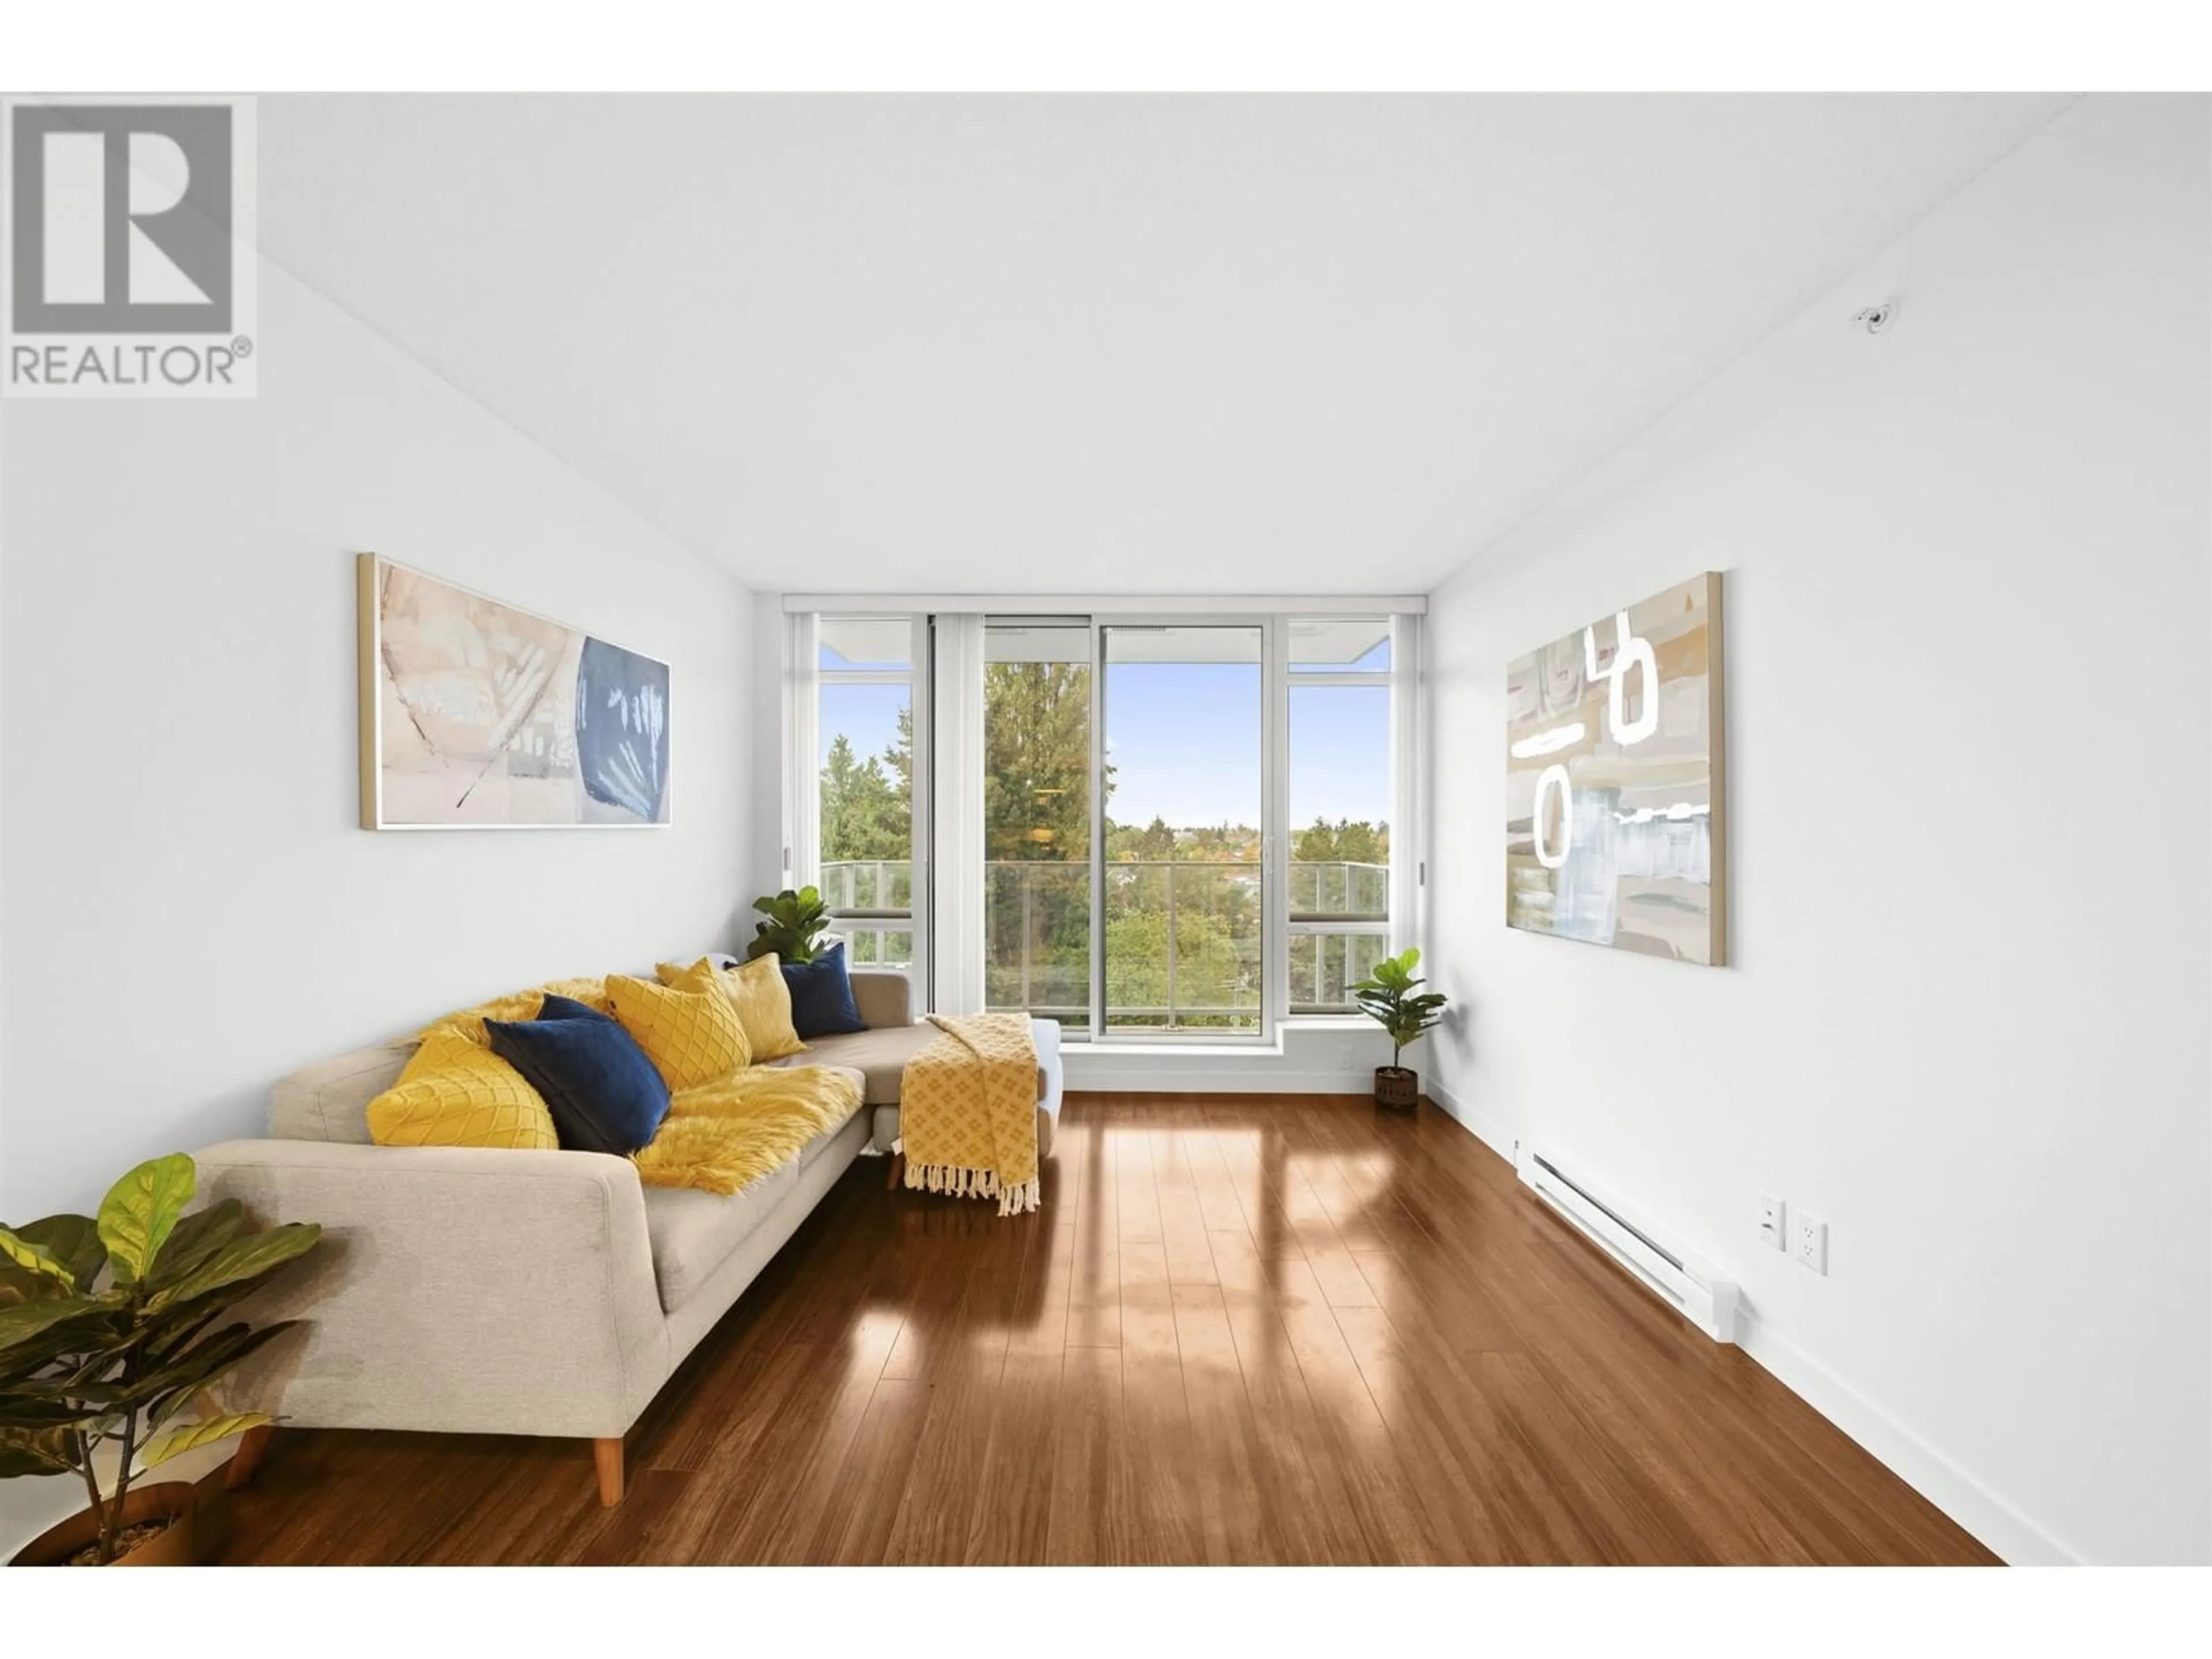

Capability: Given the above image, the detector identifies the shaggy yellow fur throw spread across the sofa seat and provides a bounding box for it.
[635,1066,861,1192]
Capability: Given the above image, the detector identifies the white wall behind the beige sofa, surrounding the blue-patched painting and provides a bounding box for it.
[0,266,774,1219]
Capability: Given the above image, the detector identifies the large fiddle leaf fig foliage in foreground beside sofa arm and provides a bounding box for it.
[0,1153,323,1566]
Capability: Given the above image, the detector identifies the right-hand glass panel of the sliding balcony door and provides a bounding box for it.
[1093,622,1270,1037]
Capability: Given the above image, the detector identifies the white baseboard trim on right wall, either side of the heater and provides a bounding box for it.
[1422,1077,2084,1566]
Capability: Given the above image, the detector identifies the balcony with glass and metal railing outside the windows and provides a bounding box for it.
[821,858,1389,1031]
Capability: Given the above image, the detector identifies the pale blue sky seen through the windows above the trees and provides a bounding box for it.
[821,664,1389,830]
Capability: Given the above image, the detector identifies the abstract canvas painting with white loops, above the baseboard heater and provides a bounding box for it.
[1506,571,1728,967]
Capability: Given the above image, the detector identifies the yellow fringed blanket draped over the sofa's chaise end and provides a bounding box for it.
[898,1013,1040,1214]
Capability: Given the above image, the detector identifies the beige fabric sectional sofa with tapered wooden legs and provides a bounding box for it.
[197,974,1062,1502]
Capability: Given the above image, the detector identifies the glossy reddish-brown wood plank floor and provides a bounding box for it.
[226,1095,1991,1564]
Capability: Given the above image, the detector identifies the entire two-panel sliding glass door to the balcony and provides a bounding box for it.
[982,617,1270,1040]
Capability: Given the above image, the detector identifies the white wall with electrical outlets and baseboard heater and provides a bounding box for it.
[1429,97,2212,1562]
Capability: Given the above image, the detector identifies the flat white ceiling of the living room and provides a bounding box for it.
[259,95,2066,593]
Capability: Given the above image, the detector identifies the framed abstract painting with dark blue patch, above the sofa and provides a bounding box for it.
[358,553,668,830]
